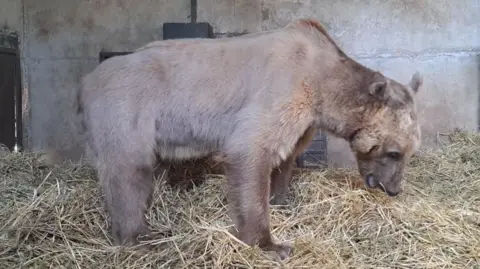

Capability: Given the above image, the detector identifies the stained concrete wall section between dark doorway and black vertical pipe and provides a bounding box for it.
[23,0,190,153]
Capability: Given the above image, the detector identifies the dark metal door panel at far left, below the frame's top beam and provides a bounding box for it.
[0,48,19,150]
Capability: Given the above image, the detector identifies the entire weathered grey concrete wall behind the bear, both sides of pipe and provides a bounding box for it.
[4,0,480,166]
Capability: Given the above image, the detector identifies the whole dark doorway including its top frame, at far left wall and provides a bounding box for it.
[0,32,22,150]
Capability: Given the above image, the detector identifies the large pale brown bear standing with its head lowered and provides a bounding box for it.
[64,17,421,258]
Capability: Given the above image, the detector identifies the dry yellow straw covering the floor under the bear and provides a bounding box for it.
[0,133,480,269]
